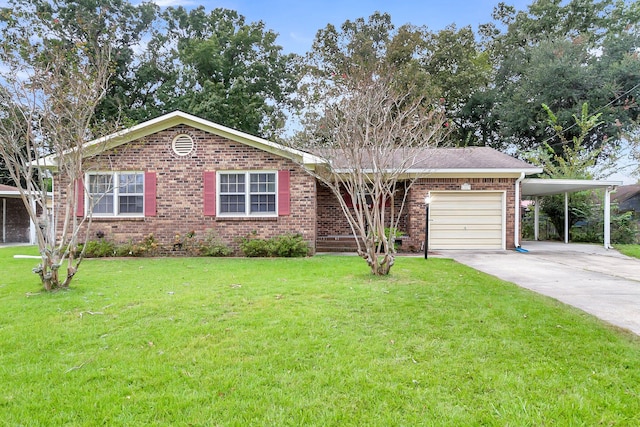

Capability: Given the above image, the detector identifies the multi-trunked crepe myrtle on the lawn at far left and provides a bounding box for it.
[0,4,112,291]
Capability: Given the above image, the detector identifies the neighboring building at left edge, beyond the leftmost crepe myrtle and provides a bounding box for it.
[0,184,32,243]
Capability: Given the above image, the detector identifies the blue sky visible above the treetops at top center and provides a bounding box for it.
[155,0,533,54]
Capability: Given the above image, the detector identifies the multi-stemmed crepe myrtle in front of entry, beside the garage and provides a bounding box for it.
[297,70,448,275]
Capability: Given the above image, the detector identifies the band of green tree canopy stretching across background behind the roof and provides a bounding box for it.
[0,0,640,187]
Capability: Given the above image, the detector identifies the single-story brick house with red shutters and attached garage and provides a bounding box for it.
[45,111,541,251]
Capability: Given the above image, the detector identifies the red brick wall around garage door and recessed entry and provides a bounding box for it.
[317,178,522,251]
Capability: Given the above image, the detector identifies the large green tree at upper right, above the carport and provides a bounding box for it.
[478,0,640,156]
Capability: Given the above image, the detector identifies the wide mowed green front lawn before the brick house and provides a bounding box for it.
[0,248,640,426]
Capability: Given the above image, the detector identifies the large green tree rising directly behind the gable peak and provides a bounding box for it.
[130,6,297,137]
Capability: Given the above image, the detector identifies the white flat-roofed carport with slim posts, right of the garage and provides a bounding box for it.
[516,178,622,249]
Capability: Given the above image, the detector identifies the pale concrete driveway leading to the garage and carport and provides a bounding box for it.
[438,242,640,335]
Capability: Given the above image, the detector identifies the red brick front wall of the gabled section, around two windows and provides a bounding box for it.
[54,125,316,251]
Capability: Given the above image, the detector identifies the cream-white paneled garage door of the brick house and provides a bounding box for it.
[429,191,505,249]
